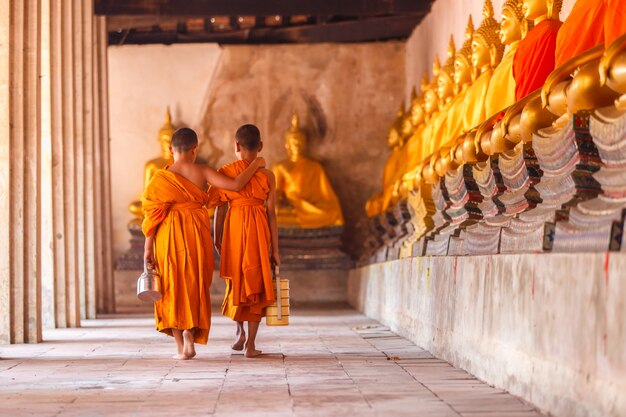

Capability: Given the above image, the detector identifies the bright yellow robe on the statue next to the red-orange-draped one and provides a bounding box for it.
[485,42,519,118]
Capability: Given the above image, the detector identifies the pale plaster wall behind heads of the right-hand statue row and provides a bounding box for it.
[405,0,576,99]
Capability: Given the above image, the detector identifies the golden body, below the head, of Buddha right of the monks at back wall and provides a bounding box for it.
[272,156,343,228]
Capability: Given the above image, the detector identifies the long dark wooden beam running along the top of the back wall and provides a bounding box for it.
[109,15,423,45]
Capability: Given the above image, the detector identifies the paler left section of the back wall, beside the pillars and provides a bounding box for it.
[108,44,222,258]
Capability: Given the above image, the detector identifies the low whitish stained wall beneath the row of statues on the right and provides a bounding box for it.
[348,253,626,417]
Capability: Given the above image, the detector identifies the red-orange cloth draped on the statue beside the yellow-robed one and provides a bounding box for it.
[513,19,562,100]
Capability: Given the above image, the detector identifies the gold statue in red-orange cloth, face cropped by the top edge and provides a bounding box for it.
[513,0,563,101]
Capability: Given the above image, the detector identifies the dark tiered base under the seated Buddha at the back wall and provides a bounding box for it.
[278,226,354,270]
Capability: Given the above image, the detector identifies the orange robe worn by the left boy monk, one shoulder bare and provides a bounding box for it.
[141,168,214,344]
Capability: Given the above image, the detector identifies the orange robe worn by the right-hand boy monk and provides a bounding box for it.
[209,161,275,322]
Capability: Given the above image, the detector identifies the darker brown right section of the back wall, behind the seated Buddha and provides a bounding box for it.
[203,42,404,255]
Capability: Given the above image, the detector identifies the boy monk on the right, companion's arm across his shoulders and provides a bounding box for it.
[209,125,280,358]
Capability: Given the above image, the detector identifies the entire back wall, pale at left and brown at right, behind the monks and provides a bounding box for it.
[109,42,405,255]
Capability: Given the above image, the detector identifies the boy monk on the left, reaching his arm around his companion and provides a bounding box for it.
[142,128,265,359]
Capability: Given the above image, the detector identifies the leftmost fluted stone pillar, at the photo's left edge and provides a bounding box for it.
[0,0,41,343]
